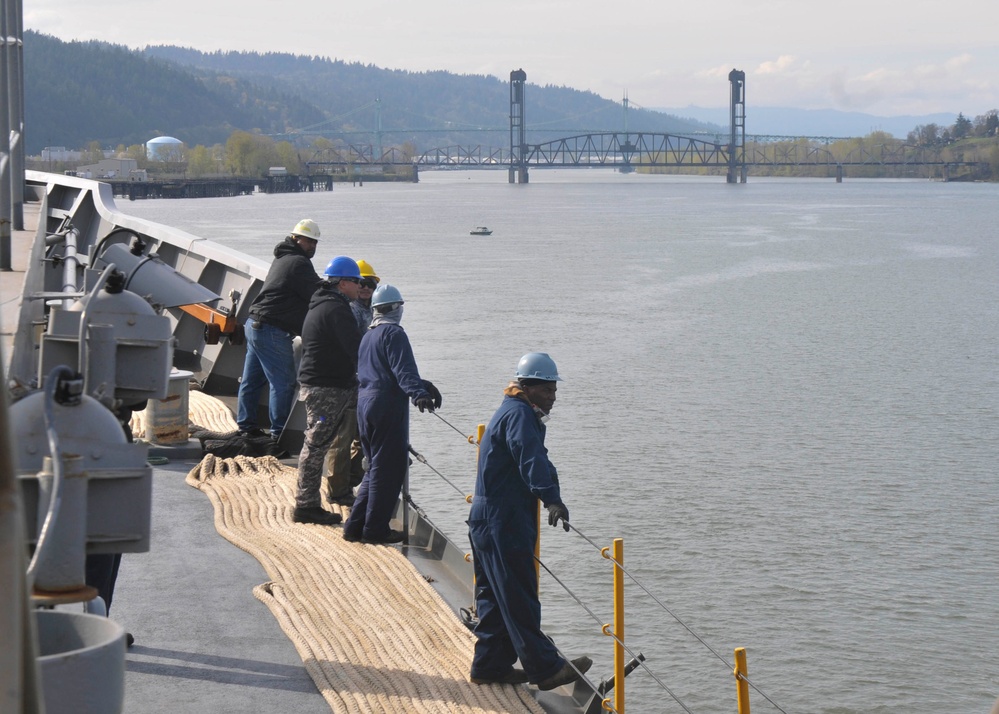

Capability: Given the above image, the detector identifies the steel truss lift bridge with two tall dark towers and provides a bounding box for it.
[306,69,976,183]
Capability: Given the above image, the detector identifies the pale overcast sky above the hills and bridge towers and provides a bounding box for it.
[24,0,999,118]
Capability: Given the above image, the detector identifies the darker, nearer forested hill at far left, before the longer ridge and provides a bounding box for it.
[24,30,324,154]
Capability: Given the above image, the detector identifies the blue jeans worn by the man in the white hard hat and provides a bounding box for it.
[236,318,296,438]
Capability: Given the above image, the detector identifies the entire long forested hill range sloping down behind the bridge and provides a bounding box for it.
[24,30,727,154]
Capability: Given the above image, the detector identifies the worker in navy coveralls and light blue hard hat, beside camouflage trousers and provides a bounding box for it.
[343,283,441,543]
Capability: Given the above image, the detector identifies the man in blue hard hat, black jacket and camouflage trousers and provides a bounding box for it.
[293,256,361,525]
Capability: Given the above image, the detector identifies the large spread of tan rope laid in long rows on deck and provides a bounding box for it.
[187,455,542,714]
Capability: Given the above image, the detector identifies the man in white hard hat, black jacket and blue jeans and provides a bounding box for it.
[236,218,322,441]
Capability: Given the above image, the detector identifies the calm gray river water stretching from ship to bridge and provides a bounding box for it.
[119,171,999,714]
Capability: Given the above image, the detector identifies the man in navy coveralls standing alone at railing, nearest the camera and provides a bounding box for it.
[468,352,593,690]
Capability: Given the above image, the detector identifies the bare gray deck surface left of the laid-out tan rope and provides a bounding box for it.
[111,461,330,714]
